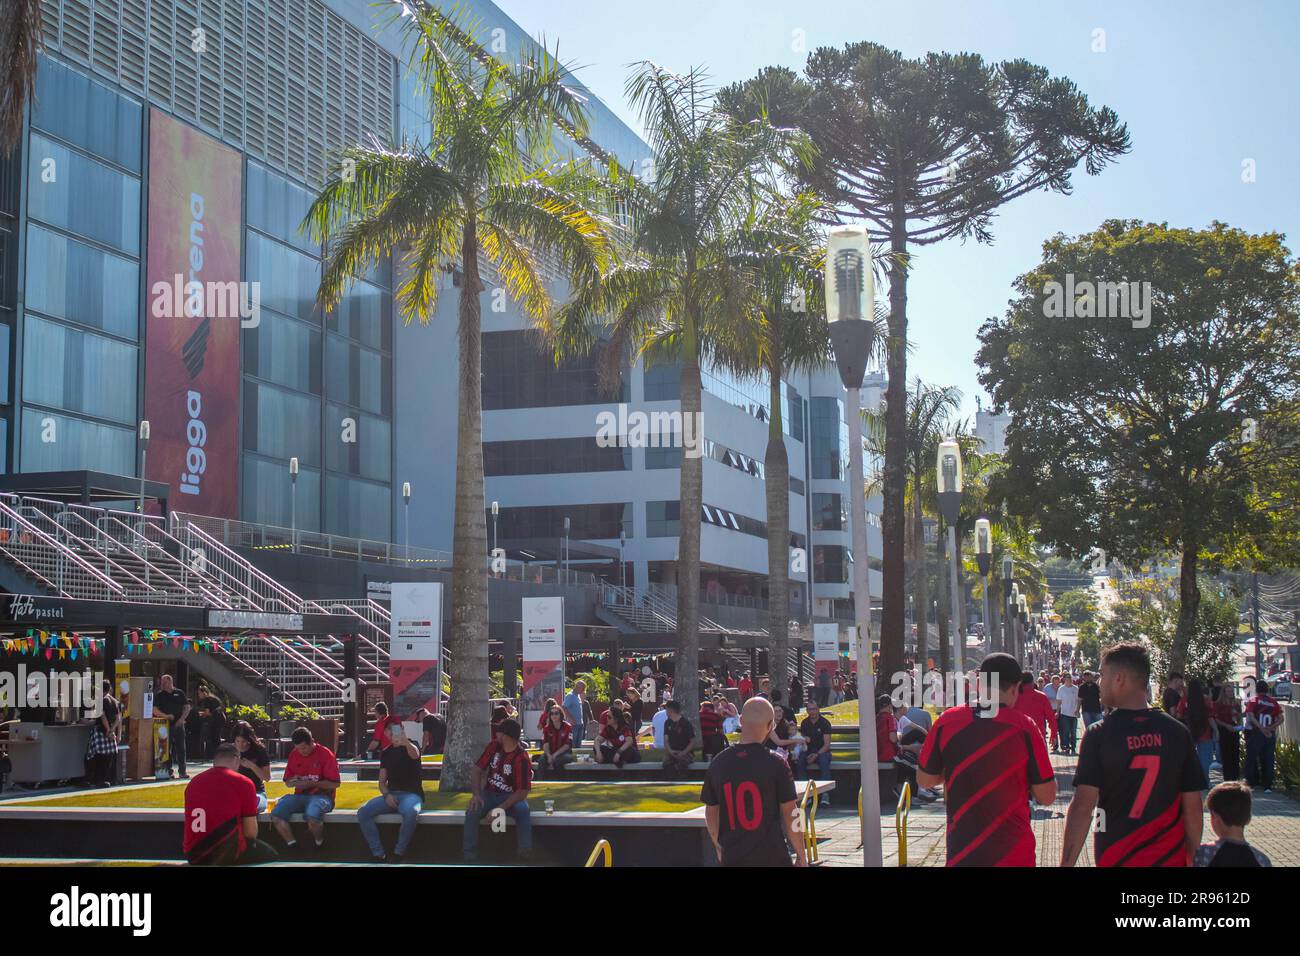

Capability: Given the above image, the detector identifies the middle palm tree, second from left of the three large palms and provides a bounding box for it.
[542,62,798,714]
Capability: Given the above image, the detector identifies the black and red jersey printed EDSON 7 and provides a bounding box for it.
[1074,710,1205,866]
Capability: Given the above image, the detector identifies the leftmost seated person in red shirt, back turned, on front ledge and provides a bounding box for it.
[181,744,278,866]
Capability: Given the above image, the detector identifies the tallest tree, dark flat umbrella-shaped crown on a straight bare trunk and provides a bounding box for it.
[719,42,1128,674]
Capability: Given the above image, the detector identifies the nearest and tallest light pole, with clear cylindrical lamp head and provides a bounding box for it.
[826,225,884,866]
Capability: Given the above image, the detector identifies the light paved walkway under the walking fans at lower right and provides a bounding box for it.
[816,754,1300,866]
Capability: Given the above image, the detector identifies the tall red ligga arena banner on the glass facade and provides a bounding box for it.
[144,109,243,518]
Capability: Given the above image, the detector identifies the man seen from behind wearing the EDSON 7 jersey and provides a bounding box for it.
[1061,644,1205,866]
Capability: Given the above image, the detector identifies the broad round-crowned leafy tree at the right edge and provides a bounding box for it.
[979,220,1300,671]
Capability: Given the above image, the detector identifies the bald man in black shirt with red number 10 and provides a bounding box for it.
[699,697,807,866]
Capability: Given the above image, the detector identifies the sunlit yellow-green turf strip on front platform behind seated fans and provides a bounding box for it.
[10,780,701,813]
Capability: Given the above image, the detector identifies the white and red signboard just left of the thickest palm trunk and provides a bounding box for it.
[389,581,442,718]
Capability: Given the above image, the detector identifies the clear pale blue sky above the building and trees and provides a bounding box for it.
[497,0,1300,415]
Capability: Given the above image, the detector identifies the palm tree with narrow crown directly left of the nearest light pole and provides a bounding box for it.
[718,191,832,693]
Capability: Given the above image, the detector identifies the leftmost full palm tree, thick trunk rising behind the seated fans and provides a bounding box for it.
[304,0,610,790]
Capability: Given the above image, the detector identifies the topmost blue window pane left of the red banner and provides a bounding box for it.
[31,56,142,173]
